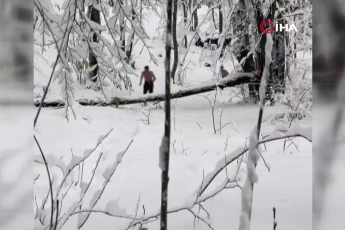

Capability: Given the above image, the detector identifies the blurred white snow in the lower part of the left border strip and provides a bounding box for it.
[0,104,34,230]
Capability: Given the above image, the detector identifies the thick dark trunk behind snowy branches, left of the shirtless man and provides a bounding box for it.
[89,2,101,82]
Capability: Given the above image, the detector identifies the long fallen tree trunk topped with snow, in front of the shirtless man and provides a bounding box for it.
[34,73,254,107]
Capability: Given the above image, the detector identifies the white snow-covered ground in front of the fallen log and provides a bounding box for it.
[35,97,312,230]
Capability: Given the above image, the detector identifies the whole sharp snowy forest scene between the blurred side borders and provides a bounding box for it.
[33,0,312,230]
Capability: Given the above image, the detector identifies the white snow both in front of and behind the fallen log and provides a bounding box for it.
[34,5,312,230]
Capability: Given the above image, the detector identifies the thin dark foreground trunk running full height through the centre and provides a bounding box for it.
[159,0,172,230]
